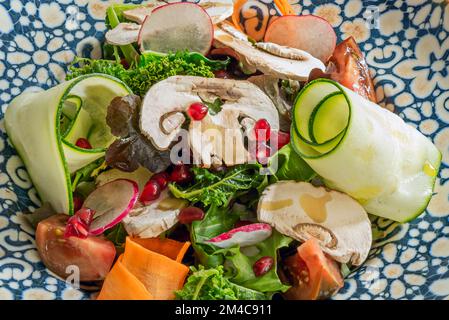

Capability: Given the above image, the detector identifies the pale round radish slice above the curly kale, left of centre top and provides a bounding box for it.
[138,2,214,54]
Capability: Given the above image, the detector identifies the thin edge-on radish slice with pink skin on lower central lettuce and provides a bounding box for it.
[207,223,272,249]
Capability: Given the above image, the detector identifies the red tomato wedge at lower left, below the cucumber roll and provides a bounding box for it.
[36,214,116,281]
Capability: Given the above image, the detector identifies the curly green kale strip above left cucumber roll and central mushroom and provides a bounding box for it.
[66,52,214,96]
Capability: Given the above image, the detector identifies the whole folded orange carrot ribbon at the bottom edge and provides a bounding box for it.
[98,237,190,300]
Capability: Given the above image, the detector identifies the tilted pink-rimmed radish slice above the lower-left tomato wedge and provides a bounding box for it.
[83,179,139,236]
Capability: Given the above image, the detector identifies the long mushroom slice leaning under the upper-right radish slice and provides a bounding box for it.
[214,21,325,81]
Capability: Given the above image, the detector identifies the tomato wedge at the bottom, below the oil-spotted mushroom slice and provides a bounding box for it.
[283,238,343,300]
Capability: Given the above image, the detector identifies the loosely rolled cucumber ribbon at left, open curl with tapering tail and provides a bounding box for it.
[5,74,132,214]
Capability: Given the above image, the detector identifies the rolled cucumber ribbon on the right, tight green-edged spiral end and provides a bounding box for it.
[291,79,441,222]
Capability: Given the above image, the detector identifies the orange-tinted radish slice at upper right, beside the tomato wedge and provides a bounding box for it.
[264,15,337,62]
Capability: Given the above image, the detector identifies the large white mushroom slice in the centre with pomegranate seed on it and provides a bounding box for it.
[140,76,279,165]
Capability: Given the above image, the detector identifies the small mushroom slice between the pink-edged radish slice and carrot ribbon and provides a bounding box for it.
[122,190,188,238]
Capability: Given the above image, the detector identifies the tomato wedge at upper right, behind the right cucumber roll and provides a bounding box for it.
[309,37,377,103]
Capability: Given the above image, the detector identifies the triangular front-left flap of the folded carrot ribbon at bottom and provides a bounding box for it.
[97,255,153,300]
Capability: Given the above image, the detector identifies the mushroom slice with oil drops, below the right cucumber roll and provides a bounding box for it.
[258,181,372,266]
